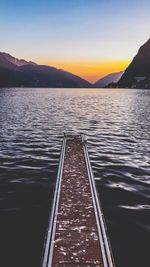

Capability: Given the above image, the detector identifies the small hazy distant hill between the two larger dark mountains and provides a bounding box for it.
[93,71,124,88]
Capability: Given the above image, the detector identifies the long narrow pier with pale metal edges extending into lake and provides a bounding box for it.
[42,135,114,267]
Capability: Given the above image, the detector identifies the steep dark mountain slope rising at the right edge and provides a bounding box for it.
[118,39,150,88]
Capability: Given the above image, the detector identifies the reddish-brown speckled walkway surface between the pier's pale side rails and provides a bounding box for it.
[49,136,104,267]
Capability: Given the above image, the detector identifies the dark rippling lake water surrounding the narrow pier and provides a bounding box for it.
[0,88,150,267]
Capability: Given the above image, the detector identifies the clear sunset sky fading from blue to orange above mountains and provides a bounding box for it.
[0,0,150,82]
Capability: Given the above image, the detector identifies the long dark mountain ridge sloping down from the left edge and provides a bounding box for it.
[0,52,92,88]
